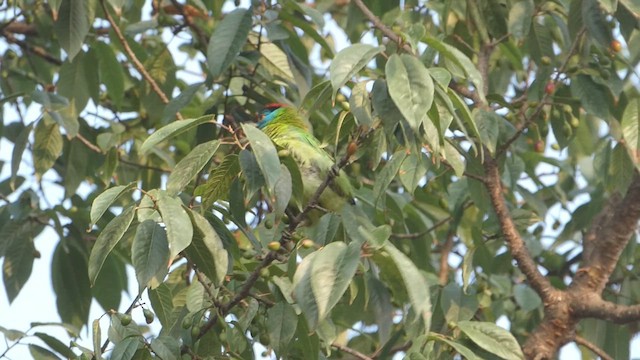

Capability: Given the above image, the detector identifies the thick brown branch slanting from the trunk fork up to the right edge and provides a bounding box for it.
[573,171,640,295]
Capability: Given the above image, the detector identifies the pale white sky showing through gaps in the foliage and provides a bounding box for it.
[0,0,640,360]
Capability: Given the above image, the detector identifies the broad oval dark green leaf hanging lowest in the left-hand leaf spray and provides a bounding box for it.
[131,220,169,289]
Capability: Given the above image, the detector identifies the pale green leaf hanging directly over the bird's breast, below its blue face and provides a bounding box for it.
[242,124,280,193]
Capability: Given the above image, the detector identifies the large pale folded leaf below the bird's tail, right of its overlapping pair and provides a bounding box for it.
[311,242,360,322]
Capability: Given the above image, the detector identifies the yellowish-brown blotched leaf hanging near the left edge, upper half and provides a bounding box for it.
[32,119,63,177]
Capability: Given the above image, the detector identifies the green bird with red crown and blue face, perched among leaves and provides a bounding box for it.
[257,104,353,212]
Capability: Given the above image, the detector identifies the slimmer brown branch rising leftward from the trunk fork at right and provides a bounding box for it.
[485,158,555,303]
